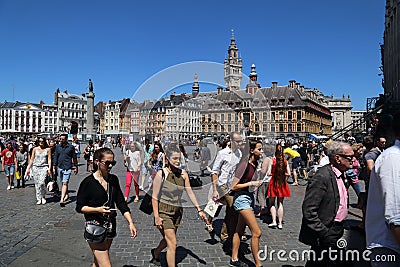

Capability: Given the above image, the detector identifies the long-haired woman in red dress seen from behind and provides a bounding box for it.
[267,144,290,229]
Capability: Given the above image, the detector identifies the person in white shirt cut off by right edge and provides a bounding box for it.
[365,112,400,267]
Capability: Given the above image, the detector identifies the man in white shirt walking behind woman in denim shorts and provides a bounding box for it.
[211,132,243,245]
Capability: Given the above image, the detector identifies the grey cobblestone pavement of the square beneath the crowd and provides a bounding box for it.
[0,149,368,266]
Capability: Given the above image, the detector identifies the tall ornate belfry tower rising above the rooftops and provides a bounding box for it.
[224,30,242,91]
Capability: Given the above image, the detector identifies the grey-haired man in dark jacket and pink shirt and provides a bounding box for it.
[299,142,354,267]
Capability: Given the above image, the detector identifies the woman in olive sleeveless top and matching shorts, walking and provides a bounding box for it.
[151,145,207,267]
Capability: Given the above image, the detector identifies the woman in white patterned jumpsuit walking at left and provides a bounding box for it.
[26,136,52,205]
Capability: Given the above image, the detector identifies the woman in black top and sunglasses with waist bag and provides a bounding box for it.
[76,148,136,266]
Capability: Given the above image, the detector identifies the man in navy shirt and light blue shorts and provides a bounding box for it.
[53,134,78,207]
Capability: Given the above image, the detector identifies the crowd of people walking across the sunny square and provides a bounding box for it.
[0,118,400,267]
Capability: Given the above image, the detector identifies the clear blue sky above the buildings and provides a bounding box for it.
[0,0,385,110]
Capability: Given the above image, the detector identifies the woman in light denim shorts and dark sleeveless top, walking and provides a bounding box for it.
[230,141,263,267]
